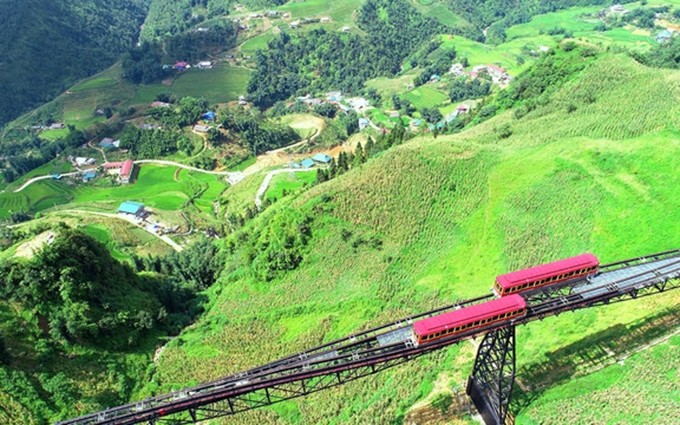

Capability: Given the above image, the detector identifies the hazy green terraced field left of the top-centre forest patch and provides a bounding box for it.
[131,64,251,105]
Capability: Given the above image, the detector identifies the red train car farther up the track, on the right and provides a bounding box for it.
[493,254,600,297]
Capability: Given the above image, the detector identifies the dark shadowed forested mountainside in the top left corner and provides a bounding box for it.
[0,0,148,127]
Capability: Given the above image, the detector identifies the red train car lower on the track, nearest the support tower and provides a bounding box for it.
[413,295,526,345]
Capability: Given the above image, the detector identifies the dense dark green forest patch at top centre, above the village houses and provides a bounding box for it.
[248,0,448,108]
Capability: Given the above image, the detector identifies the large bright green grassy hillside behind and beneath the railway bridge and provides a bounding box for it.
[148,56,680,424]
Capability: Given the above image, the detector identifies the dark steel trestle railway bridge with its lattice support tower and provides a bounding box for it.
[57,250,680,425]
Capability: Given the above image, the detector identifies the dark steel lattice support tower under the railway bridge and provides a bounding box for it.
[467,326,515,425]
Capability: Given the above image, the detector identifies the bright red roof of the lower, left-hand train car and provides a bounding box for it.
[413,294,526,336]
